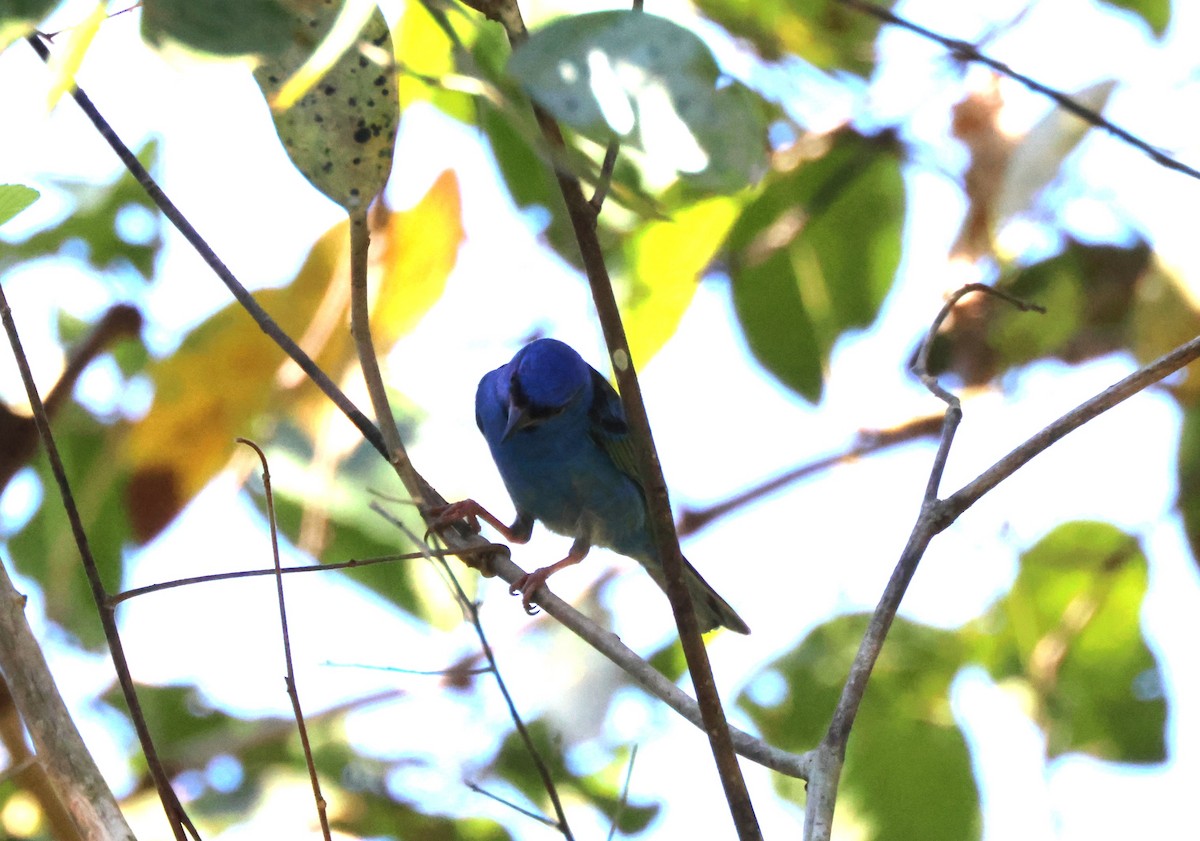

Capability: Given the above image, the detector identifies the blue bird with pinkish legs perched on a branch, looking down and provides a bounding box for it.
[438,338,750,633]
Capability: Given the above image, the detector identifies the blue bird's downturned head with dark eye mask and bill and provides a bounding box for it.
[504,338,592,438]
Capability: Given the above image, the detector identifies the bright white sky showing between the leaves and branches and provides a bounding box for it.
[0,0,1200,841]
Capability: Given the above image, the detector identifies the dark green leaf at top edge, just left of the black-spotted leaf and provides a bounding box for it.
[142,0,296,55]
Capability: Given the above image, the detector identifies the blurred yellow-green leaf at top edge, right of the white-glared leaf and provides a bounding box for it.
[696,0,892,78]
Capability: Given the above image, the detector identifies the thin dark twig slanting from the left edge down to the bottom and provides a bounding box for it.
[0,278,200,841]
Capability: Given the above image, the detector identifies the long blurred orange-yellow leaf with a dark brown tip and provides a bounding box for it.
[125,170,463,541]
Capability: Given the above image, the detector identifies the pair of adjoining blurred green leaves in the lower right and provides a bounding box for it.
[738,522,1166,840]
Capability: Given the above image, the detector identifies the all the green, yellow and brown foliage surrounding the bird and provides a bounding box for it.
[0,0,1185,840]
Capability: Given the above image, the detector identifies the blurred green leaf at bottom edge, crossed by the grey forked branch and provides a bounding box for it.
[738,614,982,841]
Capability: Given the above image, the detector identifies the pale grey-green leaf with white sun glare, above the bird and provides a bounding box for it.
[509,11,766,192]
